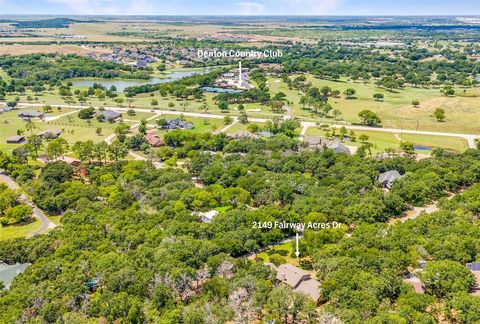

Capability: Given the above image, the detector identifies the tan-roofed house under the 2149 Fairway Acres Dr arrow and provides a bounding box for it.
[277,263,320,302]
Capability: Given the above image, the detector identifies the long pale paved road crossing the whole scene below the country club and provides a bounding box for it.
[18,103,480,148]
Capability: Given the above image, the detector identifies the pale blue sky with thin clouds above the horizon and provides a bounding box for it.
[0,0,480,15]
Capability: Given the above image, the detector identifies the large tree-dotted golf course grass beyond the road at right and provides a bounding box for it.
[269,75,480,134]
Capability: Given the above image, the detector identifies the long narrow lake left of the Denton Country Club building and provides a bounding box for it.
[72,69,209,92]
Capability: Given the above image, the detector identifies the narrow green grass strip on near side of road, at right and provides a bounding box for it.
[305,127,468,153]
